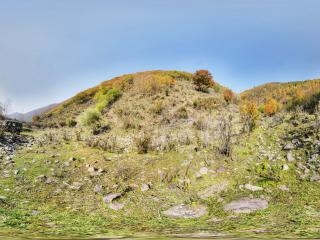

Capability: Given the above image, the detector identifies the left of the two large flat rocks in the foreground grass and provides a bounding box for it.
[162,204,207,218]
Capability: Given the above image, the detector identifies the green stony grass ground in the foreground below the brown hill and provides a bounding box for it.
[0,112,320,236]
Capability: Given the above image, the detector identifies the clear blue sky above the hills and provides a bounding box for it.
[0,0,320,112]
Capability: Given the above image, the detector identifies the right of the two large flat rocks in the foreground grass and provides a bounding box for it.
[224,198,268,213]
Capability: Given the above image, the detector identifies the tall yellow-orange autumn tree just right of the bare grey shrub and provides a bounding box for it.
[240,101,259,132]
